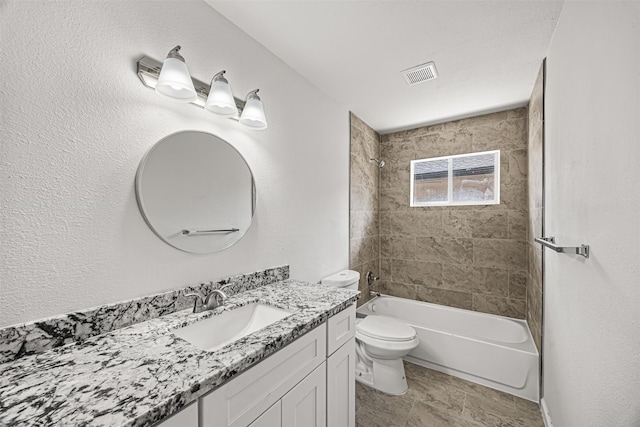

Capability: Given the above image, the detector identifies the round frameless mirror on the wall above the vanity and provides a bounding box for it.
[136,131,256,254]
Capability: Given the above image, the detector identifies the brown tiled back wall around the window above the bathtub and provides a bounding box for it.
[377,108,527,318]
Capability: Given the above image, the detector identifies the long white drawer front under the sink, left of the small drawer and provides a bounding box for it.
[200,324,327,427]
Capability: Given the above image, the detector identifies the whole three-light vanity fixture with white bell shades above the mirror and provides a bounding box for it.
[137,46,267,130]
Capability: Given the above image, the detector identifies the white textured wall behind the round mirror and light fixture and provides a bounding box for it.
[0,1,349,326]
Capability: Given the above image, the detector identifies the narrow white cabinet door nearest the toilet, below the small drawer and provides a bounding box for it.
[327,339,356,427]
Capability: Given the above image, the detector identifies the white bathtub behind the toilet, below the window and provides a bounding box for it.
[358,295,539,402]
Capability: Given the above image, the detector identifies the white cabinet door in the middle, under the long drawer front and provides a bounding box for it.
[282,363,327,427]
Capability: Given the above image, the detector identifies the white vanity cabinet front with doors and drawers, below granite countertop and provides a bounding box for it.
[196,304,355,427]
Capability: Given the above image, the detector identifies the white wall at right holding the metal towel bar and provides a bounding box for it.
[543,1,640,427]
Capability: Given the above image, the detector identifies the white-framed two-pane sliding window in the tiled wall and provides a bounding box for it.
[411,150,500,206]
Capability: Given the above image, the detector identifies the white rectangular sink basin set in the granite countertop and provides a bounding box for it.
[171,302,292,351]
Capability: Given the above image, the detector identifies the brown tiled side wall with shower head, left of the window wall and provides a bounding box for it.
[349,113,380,305]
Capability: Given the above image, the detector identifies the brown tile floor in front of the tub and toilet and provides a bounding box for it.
[356,362,544,427]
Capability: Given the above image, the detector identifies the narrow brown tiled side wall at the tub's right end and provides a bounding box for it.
[527,64,544,350]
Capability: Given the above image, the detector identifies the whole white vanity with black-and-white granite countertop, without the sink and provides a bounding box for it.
[0,280,359,427]
